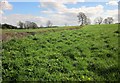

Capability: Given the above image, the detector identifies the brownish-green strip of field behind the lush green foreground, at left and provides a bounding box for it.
[0,26,80,41]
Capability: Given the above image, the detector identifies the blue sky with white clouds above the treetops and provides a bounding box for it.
[0,0,118,26]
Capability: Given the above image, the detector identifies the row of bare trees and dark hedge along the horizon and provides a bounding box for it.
[0,12,114,29]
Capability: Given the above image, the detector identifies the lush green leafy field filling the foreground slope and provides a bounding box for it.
[2,24,120,81]
